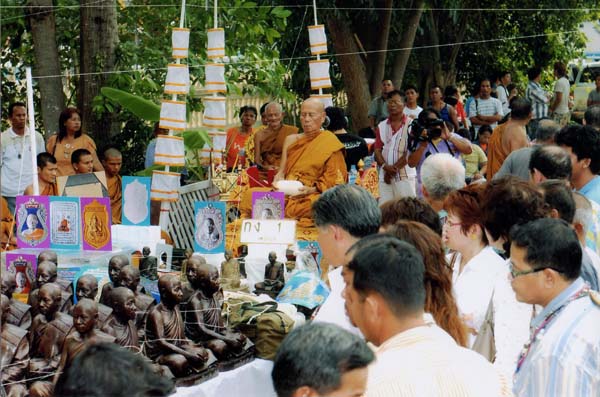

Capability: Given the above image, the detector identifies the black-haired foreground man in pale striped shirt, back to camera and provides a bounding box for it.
[342,234,512,397]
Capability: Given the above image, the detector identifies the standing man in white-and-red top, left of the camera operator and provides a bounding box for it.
[374,90,416,203]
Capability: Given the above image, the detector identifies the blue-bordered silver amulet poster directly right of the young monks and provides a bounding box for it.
[121,176,152,226]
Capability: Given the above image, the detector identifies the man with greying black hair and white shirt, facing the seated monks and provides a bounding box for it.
[312,185,381,334]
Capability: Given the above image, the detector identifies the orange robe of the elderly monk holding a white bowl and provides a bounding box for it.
[239,131,347,227]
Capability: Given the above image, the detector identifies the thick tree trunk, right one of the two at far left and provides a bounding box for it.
[77,0,119,142]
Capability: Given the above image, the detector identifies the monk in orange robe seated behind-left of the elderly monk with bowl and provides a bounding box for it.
[254,102,298,170]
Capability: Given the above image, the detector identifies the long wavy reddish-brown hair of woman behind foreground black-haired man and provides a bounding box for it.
[386,221,468,347]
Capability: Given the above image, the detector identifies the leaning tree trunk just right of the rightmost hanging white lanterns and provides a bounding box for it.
[327,15,371,131]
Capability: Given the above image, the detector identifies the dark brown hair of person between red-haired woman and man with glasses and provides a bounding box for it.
[481,176,547,253]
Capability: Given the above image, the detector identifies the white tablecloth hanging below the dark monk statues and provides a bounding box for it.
[174,358,277,397]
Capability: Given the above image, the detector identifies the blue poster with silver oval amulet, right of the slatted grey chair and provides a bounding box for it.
[194,201,225,254]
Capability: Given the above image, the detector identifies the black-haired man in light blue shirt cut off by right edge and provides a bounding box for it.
[556,125,600,204]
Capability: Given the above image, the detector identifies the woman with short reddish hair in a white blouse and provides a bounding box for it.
[442,185,528,376]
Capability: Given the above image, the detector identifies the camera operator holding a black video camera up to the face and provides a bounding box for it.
[408,108,473,197]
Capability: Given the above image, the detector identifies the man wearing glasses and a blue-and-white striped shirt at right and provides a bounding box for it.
[510,218,600,397]
